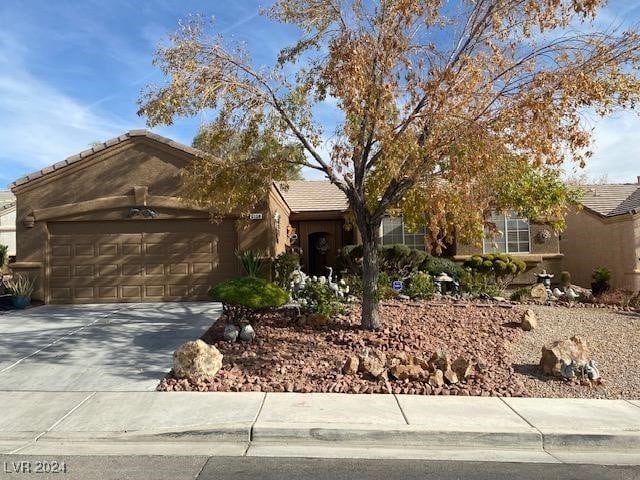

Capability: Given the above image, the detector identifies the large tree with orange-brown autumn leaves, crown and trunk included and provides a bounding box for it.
[139,0,640,329]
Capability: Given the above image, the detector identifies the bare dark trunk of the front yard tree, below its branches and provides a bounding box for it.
[360,222,381,330]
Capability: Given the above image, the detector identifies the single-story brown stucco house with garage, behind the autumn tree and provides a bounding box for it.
[12,130,561,303]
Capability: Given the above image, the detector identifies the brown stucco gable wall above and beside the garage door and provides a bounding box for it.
[13,137,272,300]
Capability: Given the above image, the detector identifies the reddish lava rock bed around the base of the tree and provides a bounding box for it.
[158,301,527,396]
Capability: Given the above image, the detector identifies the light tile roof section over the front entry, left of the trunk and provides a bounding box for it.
[278,180,349,212]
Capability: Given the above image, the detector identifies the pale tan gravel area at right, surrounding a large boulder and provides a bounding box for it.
[512,306,640,399]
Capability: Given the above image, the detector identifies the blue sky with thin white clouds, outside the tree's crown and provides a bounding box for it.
[0,0,640,188]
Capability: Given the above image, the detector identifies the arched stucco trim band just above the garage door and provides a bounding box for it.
[32,195,208,222]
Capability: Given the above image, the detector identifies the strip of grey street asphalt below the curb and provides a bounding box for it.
[0,455,640,480]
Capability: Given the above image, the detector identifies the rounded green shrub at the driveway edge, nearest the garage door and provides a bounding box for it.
[209,277,289,325]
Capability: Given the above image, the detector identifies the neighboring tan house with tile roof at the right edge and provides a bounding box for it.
[560,181,640,291]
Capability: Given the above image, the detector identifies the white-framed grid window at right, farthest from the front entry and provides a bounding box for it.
[484,213,531,253]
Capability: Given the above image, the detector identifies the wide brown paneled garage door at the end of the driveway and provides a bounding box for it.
[48,219,237,303]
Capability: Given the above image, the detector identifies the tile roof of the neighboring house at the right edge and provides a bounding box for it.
[580,183,640,217]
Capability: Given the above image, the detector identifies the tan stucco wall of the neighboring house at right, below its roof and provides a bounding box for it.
[560,209,640,291]
